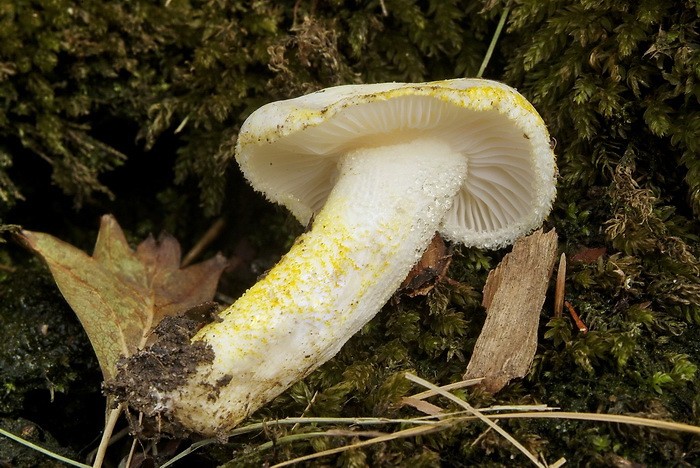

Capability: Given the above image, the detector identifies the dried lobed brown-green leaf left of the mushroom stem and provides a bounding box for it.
[20,215,226,380]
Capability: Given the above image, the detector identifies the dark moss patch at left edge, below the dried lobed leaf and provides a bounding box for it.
[0,261,104,443]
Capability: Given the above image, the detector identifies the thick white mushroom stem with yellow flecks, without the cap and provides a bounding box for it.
[167,139,467,434]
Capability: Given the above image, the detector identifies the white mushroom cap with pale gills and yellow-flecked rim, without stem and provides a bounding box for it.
[236,79,557,248]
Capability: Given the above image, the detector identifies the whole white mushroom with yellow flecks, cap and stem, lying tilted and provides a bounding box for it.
[115,79,556,435]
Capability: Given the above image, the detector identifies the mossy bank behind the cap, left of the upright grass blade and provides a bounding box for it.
[0,0,486,215]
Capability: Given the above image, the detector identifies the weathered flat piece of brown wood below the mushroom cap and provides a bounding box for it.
[464,229,557,393]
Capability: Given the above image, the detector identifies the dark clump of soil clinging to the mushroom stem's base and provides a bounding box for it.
[104,315,216,438]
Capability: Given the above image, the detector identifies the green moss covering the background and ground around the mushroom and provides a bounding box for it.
[0,0,700,466]
